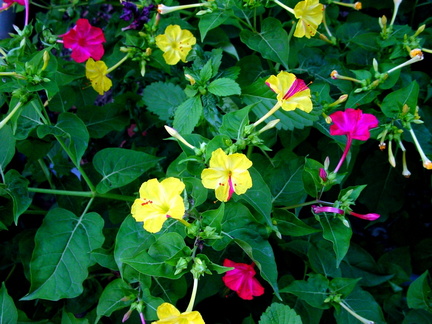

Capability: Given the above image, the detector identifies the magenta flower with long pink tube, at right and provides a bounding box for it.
[329,108,378,173]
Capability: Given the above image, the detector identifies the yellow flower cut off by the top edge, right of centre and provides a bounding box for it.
[294,0,324,38]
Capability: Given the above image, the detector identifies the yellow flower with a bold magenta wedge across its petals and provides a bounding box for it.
[266,71,312,112]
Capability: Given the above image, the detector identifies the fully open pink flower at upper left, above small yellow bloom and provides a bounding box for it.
[62,19,105,63]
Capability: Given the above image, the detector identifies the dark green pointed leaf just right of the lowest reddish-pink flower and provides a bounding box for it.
[280,274,330,309]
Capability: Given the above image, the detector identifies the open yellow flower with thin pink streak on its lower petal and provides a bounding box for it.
[201,148,252,201]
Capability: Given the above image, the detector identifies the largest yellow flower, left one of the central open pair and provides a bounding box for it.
[131,178,185,233]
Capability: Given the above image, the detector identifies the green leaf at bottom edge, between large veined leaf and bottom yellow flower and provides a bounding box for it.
[96,278,137,323]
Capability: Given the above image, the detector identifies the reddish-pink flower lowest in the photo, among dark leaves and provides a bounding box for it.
[222,259,264,300]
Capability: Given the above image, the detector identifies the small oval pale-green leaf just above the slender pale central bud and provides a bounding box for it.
[173,96,203,134]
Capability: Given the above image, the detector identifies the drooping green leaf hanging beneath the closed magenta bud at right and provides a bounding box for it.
[319,213,352,267]
